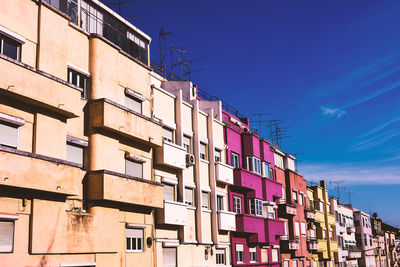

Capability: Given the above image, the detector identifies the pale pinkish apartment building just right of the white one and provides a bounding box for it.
[353,208,375,267]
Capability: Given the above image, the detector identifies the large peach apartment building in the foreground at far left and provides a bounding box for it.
[0,0,164,266]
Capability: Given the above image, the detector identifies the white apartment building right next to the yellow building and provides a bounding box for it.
[330,200,361,267]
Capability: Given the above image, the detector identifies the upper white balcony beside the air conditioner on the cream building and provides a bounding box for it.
[155,141,186,170]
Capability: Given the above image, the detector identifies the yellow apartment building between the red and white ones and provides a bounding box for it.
[309,181,338,267]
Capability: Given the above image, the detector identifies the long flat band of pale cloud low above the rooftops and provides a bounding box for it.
[299,162,400,184]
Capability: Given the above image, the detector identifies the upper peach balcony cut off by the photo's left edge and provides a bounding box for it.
[0,55,82,118]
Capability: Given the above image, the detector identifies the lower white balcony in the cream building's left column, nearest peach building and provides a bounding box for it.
[157,200,187,226]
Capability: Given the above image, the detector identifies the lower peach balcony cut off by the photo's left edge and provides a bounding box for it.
[0,146,85,195]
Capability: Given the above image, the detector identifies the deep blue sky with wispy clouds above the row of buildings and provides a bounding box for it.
[104,0,400,226]
